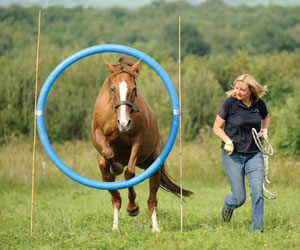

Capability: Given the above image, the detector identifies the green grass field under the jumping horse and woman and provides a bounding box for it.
[0,137,300,249]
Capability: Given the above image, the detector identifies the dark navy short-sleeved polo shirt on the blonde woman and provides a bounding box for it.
[218,97,268,153]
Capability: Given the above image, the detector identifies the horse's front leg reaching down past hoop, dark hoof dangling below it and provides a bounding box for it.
[125,143,140,216]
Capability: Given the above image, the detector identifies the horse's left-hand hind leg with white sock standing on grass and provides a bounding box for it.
[98,154,122,231]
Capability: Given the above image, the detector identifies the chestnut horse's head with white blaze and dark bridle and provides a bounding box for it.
[105,57,140,132]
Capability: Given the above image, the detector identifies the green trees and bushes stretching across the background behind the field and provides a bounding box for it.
[0,0,300,155]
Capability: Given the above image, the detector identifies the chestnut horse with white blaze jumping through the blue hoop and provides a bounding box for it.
[91,56,193,232]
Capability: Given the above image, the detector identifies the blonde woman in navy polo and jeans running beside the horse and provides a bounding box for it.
[214,74,270,232]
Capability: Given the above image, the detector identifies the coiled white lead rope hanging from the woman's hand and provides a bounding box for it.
[252,128,277,200]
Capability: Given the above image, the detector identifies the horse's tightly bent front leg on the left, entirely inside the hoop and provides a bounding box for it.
[94,129,124,175]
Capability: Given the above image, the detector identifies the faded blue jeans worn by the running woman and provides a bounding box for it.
[222,149,264,231]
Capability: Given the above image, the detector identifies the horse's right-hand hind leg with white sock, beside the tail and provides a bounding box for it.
[148,170,160,232]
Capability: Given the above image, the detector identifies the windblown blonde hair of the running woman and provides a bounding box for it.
[226,74,268,102]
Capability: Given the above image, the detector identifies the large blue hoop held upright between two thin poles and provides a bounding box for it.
[35,44,180,190]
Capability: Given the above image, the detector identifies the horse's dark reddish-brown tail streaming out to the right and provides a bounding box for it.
[160,164,194,197]
